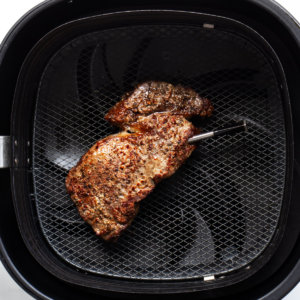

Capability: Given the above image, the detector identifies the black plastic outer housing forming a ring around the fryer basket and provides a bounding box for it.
[0,0,300,299]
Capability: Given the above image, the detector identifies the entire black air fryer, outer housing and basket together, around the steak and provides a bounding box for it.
[0,0,300,300]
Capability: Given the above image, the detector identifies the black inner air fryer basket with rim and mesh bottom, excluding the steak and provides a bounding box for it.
[12,11,293,293]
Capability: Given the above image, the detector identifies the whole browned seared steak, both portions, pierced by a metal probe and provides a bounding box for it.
[66,82,213,241]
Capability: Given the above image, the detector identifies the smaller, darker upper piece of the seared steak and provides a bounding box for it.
[105,81,214,128]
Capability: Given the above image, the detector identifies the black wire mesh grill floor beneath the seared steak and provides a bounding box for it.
[33,25,285,279]
